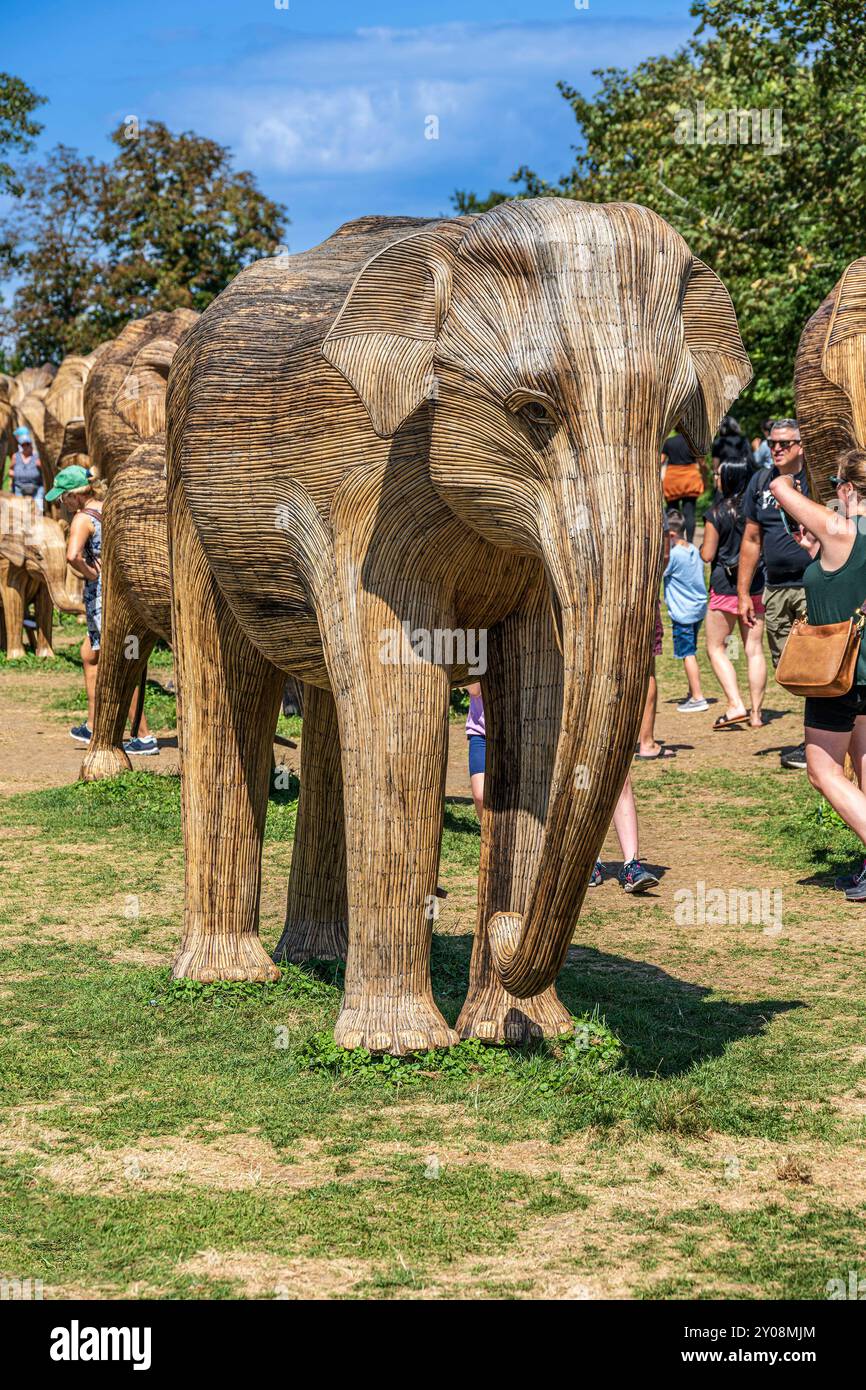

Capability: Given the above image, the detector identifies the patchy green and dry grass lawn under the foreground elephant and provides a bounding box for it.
[0,634,866,1298]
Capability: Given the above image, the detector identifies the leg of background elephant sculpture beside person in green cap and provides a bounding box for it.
[78,557,156,781]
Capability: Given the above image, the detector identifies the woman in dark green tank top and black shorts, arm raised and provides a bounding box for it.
[770,449,866,902]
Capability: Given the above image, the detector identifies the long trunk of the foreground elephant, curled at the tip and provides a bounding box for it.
[488,446,662,998]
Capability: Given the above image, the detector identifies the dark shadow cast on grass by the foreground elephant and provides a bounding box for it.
[428,934,805,1077]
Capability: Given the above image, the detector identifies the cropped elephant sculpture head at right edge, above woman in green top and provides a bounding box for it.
[794,256,866,502]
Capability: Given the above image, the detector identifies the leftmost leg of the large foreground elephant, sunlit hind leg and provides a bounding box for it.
[172,503,285,981]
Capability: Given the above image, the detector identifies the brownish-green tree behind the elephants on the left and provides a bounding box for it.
[0,121,286,364]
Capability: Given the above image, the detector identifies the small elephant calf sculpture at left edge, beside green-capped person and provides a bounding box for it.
[0,493,83,660]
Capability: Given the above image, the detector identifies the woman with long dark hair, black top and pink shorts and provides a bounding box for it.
[701,459,767,728]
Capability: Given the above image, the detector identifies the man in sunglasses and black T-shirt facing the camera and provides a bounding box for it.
[737,420,812,770]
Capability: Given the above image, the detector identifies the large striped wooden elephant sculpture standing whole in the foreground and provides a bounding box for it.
[167,199,751,1054]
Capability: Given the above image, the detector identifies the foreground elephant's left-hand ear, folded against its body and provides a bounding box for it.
[321,218,466,439]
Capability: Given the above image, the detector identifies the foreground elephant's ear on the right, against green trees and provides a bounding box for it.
[680,256,752,455]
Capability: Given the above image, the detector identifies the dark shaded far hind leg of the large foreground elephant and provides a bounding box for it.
[274,685,349,962]
